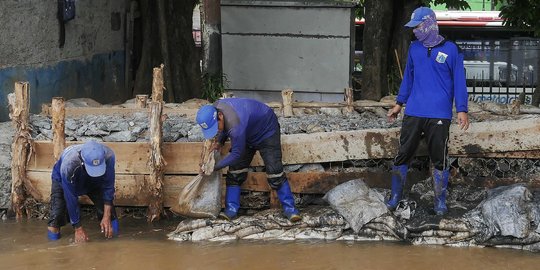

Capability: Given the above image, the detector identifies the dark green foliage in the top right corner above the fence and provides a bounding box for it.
[494,0,540,37]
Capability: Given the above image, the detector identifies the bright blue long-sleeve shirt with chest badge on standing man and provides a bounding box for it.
[396,41,468,119]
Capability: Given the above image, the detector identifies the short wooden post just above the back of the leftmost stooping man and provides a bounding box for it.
[52,97,66,160]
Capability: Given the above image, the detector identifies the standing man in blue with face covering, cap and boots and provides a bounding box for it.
[386,7,469,215]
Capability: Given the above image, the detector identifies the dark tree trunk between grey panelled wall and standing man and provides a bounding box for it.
[361,0,394,100]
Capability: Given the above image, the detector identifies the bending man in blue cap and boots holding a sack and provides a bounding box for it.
[197,98,301,222]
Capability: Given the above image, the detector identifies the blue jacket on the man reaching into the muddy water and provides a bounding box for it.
[51,144,115,227]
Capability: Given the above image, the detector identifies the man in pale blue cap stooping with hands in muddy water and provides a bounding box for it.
[47,141,118,243]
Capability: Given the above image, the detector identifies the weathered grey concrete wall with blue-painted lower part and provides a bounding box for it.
[0,0,128,121]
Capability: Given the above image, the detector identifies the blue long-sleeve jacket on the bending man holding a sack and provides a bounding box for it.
[214,98,279,170]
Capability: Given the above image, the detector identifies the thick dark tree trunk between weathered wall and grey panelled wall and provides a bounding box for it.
[133,0,201,102]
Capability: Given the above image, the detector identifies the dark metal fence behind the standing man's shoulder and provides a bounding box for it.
[456,38,540,104]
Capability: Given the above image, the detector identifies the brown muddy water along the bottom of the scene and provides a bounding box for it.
[0,218,540,270]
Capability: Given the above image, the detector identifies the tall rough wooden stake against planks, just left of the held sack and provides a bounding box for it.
[147,101,166,222]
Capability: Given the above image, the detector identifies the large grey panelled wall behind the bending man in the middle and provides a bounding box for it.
[221,1,354,101]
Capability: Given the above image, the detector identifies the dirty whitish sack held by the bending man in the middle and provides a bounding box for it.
[170,151,221,218]
